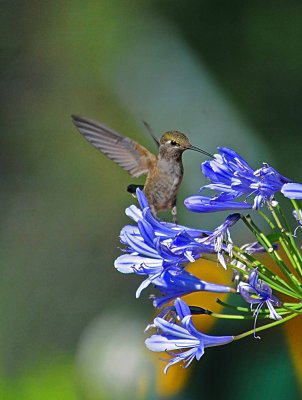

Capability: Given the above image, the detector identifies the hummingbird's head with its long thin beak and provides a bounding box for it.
[160,131,214,158]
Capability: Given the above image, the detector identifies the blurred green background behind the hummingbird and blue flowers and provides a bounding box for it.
[0,0,302,400]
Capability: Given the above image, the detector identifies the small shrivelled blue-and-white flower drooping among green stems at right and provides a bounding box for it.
[237,268,282,335]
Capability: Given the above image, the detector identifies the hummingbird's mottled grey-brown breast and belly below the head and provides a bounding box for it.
[144,159,183,212]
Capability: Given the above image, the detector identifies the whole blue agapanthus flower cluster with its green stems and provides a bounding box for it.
[115,148,302,372]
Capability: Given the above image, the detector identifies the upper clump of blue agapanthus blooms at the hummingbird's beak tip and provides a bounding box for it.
[185,147,290,212]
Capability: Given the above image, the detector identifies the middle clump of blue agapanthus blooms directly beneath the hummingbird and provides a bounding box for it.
[115,189,234,304]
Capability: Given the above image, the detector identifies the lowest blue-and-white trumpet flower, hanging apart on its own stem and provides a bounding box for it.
[145,298,234,373]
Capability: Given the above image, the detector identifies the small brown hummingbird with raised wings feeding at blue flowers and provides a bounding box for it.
[71,115,214,223]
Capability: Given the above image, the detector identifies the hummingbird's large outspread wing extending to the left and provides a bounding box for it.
[72,115,156,177]
